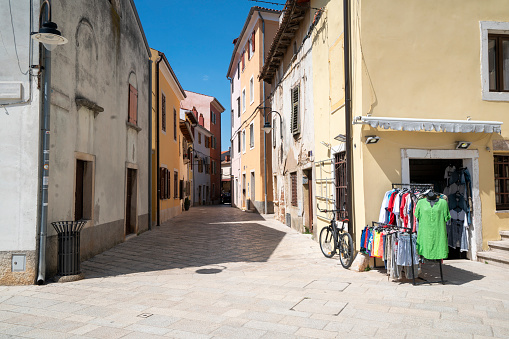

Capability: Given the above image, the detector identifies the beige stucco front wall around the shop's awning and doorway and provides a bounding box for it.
[353,0,509,249]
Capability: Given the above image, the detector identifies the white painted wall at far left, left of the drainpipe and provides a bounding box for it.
[0,0,40,252]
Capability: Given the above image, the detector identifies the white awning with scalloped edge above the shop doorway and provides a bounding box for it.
[354,116,502,133]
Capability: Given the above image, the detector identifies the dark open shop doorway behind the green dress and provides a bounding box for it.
[409,159,471,259]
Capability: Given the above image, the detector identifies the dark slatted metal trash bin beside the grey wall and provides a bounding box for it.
[51,220,87,276]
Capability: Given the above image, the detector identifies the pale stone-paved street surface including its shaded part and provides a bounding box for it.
[0,206,509,338]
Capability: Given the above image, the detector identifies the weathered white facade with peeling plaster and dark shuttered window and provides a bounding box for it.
[270,14,316,228]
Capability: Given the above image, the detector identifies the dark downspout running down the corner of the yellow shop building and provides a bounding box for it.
[343,0,355,239]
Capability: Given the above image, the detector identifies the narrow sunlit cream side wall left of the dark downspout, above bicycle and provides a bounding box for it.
[311,0,345,237]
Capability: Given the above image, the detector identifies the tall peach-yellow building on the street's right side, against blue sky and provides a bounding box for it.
[227,6,280,213]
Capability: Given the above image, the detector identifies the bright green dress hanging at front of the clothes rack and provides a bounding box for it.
[415,198,451,260]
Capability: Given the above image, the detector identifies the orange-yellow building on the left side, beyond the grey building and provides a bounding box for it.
[151,49,189,225]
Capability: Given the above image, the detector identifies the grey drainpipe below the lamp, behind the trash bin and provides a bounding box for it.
[37,48,51,285]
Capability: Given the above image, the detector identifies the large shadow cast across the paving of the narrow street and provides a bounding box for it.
[82,206,286,279]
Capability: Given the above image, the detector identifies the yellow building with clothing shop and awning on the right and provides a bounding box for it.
[311,0,509,261]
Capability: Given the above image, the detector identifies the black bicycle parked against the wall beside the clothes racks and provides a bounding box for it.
[317,207,354,268]
